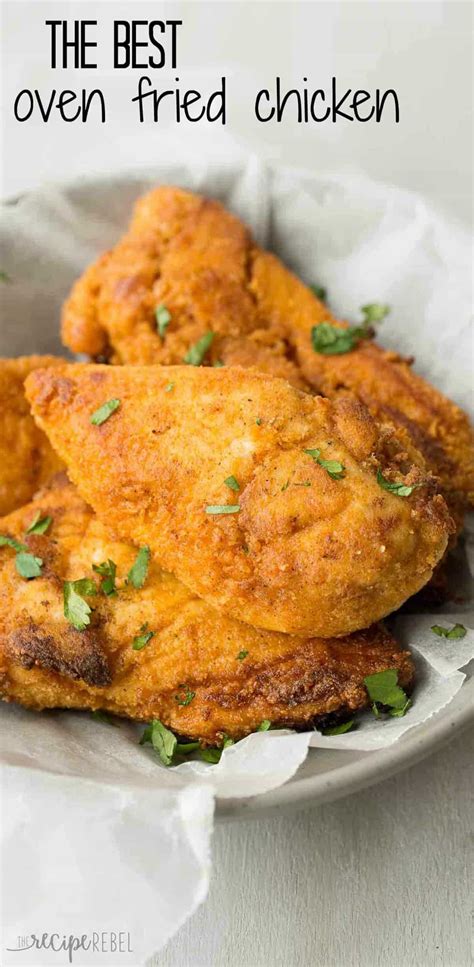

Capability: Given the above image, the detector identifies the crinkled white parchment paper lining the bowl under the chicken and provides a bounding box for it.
[0,159,474,967]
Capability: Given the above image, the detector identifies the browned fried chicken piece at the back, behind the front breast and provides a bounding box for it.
[63,187,474,528]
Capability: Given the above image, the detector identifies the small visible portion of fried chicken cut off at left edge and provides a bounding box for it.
[0,356,64,515]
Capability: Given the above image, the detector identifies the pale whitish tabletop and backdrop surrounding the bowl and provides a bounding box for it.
[2,0,474,967]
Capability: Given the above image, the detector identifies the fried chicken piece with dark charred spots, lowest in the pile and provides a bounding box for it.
[0,474,413,742]
